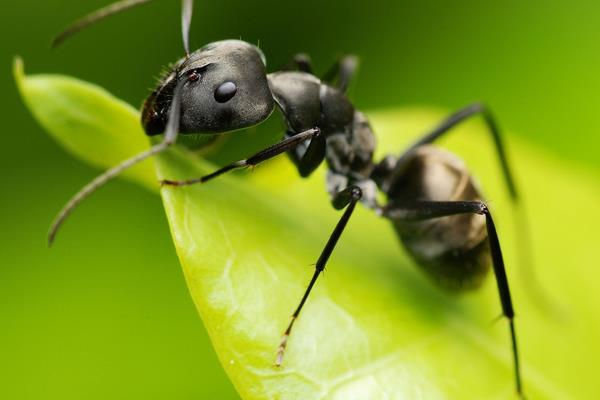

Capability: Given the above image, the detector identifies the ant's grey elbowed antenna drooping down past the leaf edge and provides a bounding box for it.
[48,81,185,246]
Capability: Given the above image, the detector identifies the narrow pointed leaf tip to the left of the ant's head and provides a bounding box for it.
[13,58,156,192]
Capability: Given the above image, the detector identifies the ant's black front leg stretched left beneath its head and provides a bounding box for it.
[160,128,321,186]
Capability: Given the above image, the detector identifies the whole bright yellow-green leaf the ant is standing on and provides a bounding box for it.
[18,60,600,400]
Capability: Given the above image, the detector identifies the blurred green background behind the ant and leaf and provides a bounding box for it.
[0,0,600,399]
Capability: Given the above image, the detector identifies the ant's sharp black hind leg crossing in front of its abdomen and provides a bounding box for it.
[383,201,524,398]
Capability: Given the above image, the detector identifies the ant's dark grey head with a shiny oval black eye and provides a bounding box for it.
[142,40,274,135]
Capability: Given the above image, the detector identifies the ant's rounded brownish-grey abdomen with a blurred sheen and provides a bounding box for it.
[388,145,491,290]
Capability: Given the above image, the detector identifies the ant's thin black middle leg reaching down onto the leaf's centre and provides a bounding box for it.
[275,186,362,367]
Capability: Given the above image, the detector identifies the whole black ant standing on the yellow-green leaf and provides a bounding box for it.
[48,0,523,397]
